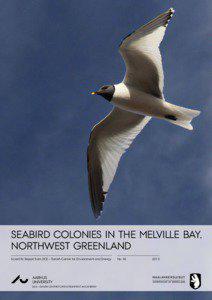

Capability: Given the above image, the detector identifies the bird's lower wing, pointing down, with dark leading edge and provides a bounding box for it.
[87,108,151,218]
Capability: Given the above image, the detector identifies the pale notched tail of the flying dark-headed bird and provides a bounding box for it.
[165,103,201,130]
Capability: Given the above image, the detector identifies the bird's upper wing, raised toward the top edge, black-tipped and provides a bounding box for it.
[119,8,174,98]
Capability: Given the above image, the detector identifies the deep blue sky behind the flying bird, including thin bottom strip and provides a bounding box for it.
[0,0,212,300]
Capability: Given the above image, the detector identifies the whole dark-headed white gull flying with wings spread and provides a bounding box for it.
[87,8,200,218]
